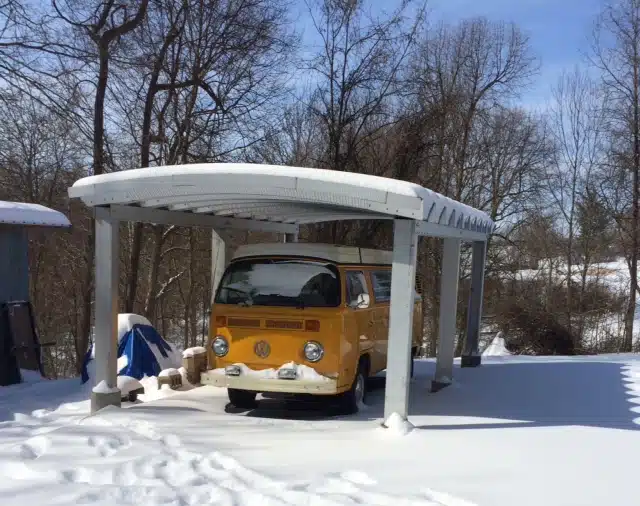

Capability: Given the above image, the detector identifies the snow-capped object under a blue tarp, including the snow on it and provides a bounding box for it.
[82,314,181,383]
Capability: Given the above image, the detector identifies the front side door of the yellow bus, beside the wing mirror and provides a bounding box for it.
[345,270,375,376]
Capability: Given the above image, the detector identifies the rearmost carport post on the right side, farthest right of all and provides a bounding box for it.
[460,241,487,367]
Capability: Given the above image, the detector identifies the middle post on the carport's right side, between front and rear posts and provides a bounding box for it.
[433,238,460,390]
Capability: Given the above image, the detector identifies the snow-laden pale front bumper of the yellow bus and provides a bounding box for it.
[200,370,338,395]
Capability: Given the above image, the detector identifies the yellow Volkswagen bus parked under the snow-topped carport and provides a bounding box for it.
[201,243,422,412]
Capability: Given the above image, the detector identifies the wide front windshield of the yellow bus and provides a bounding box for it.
[215,259,340,308]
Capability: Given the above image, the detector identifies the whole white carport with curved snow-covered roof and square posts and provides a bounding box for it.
[69,163,494,419]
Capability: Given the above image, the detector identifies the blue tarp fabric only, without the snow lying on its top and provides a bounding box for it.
[82,324,172,383]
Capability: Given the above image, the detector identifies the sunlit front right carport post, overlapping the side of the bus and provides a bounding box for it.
[384,219,418,420]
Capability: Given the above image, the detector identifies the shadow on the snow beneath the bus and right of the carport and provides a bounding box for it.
[220,361,640,430]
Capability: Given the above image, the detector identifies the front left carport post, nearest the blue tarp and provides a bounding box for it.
[91,209,121,413]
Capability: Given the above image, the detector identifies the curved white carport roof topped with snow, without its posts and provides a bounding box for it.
[69,163,494,238]
